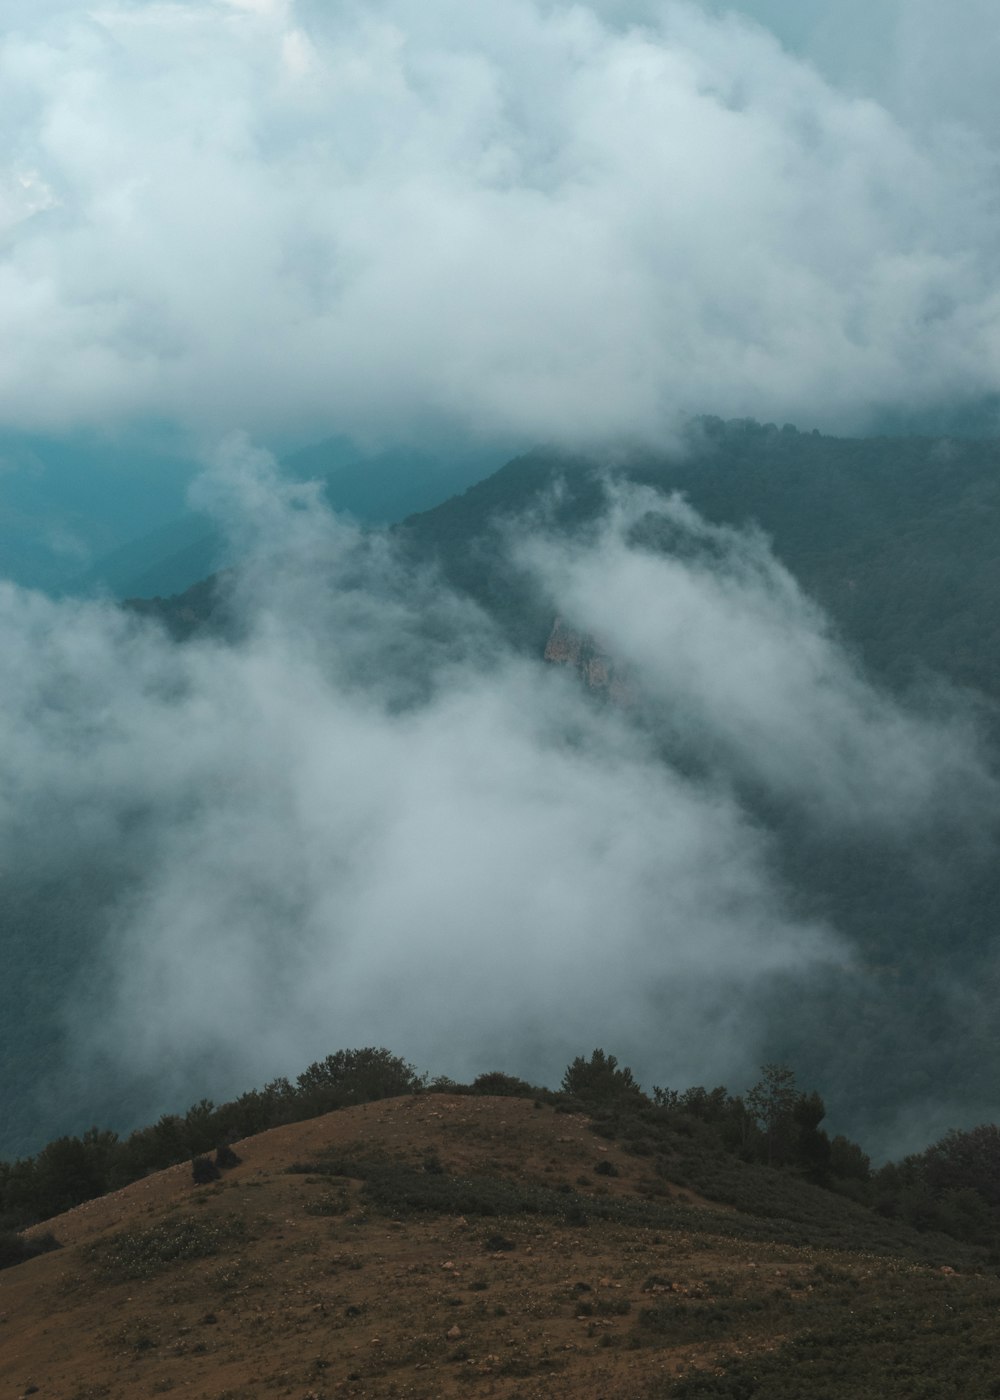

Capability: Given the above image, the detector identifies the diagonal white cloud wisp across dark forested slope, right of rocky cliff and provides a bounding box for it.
[520,489,1000,841]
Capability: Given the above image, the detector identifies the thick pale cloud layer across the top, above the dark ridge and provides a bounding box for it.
[0,0,1000,442]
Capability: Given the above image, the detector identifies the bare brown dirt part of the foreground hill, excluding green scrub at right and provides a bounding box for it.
[0,1095,1000,1400]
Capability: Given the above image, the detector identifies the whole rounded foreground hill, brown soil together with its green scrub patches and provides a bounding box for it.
[0,1091,1000,1400]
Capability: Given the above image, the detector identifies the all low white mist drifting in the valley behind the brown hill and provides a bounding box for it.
[0,440,993,1148]
